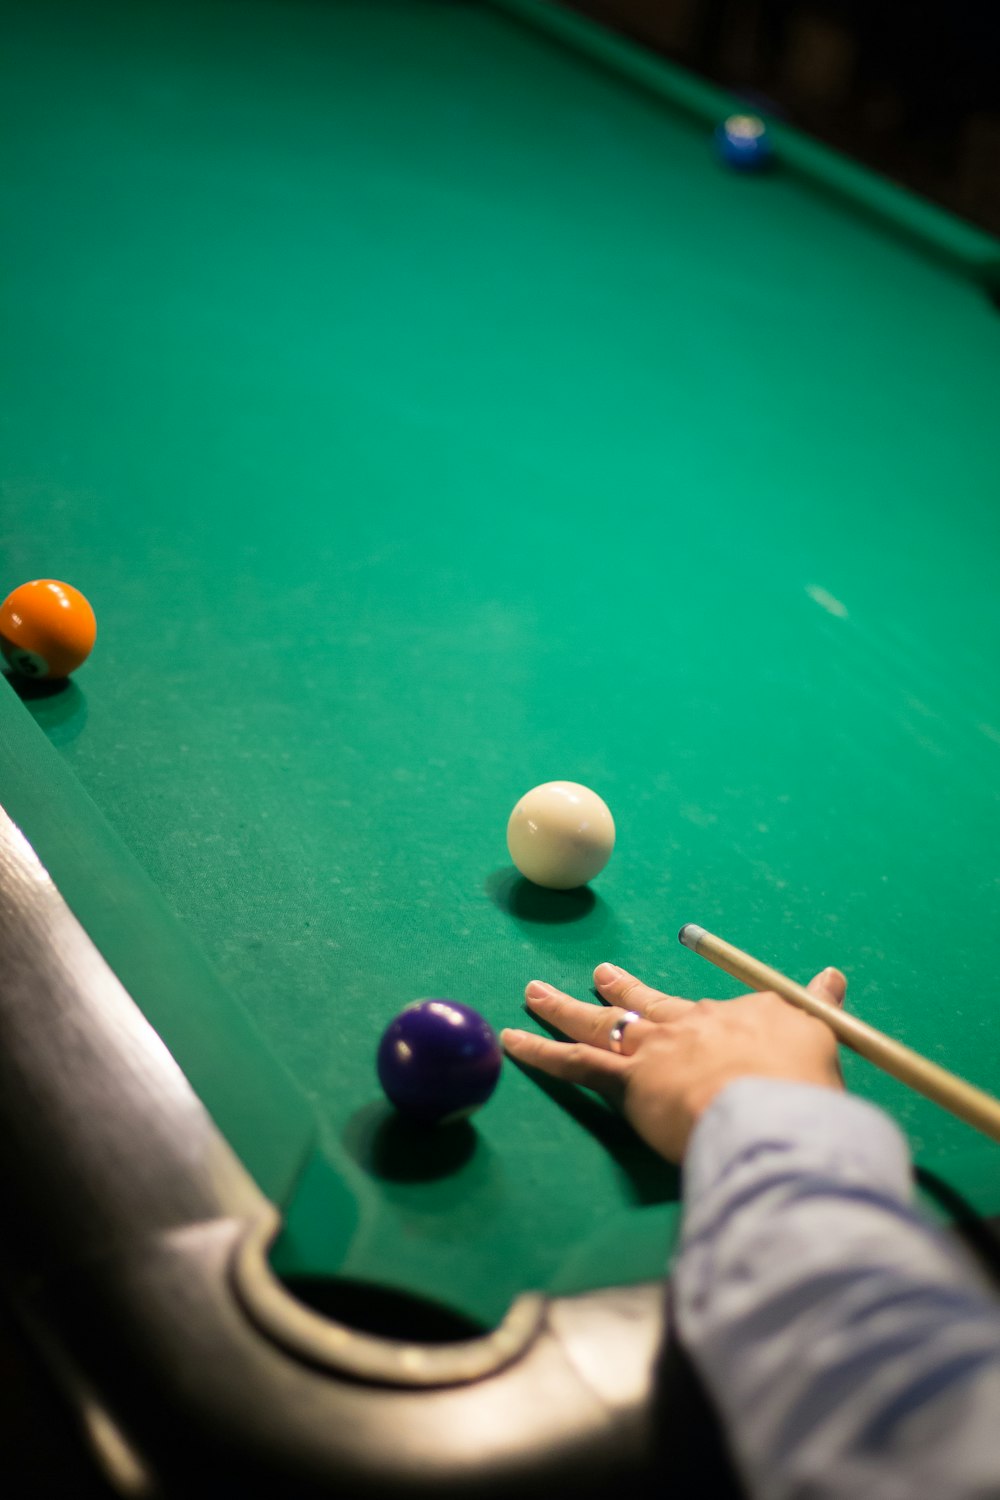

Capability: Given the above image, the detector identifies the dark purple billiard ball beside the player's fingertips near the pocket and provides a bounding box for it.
[378,999,504,1125]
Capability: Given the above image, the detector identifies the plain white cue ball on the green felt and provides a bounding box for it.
[507,782,615,891]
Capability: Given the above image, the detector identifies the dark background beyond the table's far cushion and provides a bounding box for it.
[565,0,1000,234]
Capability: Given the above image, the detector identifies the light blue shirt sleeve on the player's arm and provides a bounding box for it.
[673,1079,1000,1500]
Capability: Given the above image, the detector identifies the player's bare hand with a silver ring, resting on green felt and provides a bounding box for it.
[501,963,847,1163]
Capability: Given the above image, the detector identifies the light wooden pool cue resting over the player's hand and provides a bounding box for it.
[678,923,1000,1140]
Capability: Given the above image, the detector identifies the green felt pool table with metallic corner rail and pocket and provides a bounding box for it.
[0,0,1000,1500]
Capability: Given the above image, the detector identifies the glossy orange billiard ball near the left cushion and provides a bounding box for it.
[0,578,97,678]
